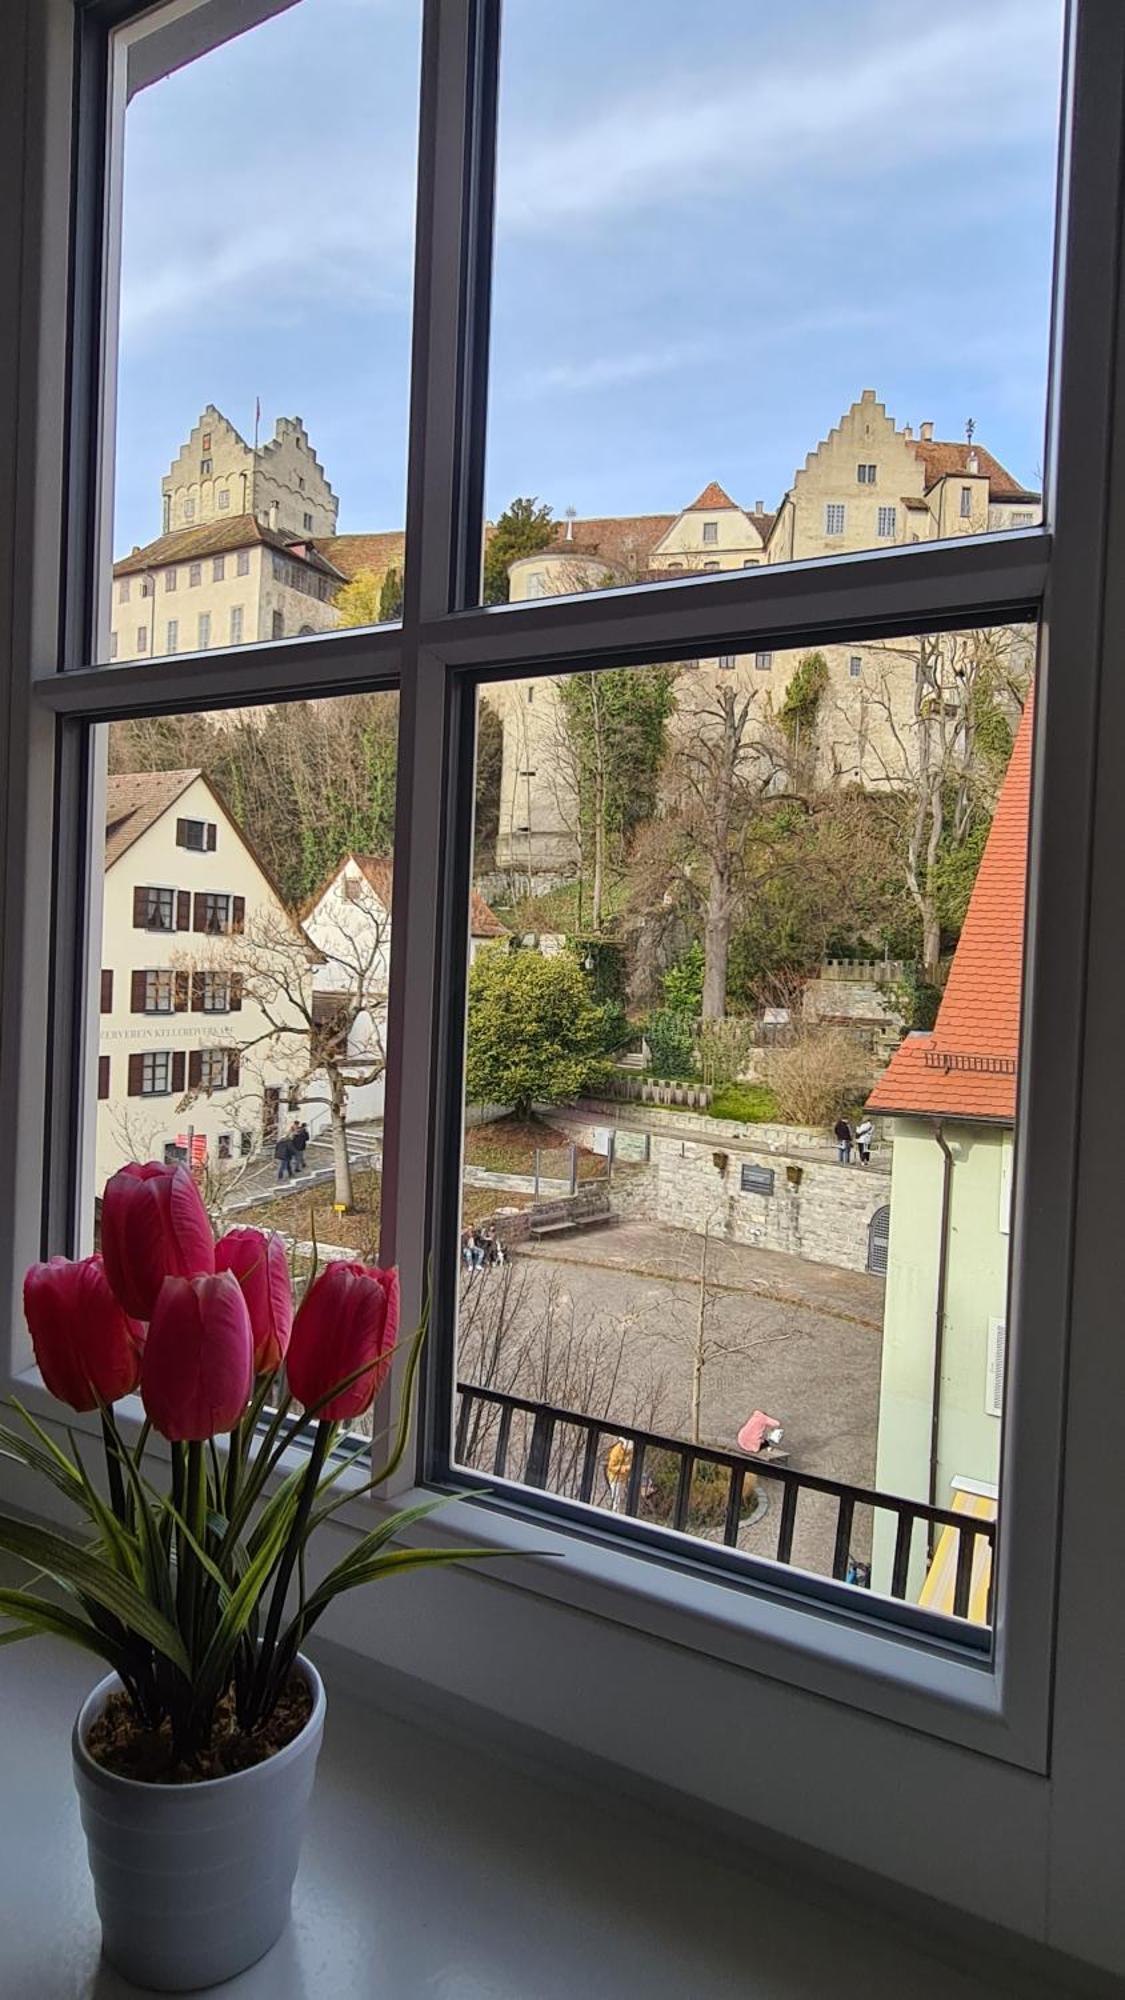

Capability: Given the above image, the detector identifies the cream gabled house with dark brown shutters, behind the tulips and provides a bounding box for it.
[96,770,314,1190]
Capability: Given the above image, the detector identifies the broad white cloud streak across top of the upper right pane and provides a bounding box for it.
[498,0,1057,232]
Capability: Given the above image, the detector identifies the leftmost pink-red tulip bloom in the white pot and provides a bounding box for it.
[24,1256,144,1410]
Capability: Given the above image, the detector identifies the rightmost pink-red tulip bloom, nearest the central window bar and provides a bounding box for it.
[286,1264,398,1424]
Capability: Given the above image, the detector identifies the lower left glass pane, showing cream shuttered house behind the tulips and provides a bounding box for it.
[88,694,398,1440]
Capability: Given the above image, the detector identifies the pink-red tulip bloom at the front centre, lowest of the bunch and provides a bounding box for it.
[140,1270,254,1442]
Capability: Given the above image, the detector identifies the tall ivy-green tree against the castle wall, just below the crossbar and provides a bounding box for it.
[556,666,677,932]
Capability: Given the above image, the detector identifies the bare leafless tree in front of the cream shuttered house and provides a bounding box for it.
[212,882,390,1210]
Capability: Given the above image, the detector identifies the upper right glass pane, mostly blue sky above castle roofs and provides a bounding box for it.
[484,0,1063,602]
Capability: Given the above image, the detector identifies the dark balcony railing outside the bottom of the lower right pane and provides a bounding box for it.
[454,1382,997,1624]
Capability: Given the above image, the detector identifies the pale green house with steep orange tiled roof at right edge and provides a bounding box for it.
[867,698,1033,1590]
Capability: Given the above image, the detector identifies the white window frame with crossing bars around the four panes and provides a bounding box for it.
[0,0,1125,1970]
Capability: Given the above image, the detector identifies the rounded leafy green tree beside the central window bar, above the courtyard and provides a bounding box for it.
[464,952,613,1116]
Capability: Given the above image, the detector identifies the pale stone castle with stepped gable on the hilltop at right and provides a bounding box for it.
[488,390,1041,888]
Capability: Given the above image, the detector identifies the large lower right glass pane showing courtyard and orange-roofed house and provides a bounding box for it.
[454,628,1035,1624]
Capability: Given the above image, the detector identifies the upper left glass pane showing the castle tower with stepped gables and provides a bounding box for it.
[96,0,420,660]
